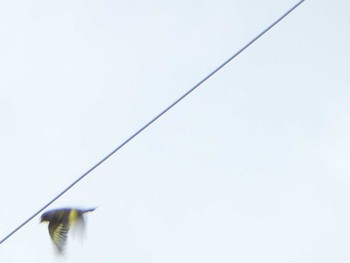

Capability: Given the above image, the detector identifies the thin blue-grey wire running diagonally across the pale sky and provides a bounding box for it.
[0,0,305,248]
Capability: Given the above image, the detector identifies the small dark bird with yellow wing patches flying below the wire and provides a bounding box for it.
[40,207,96,254]
